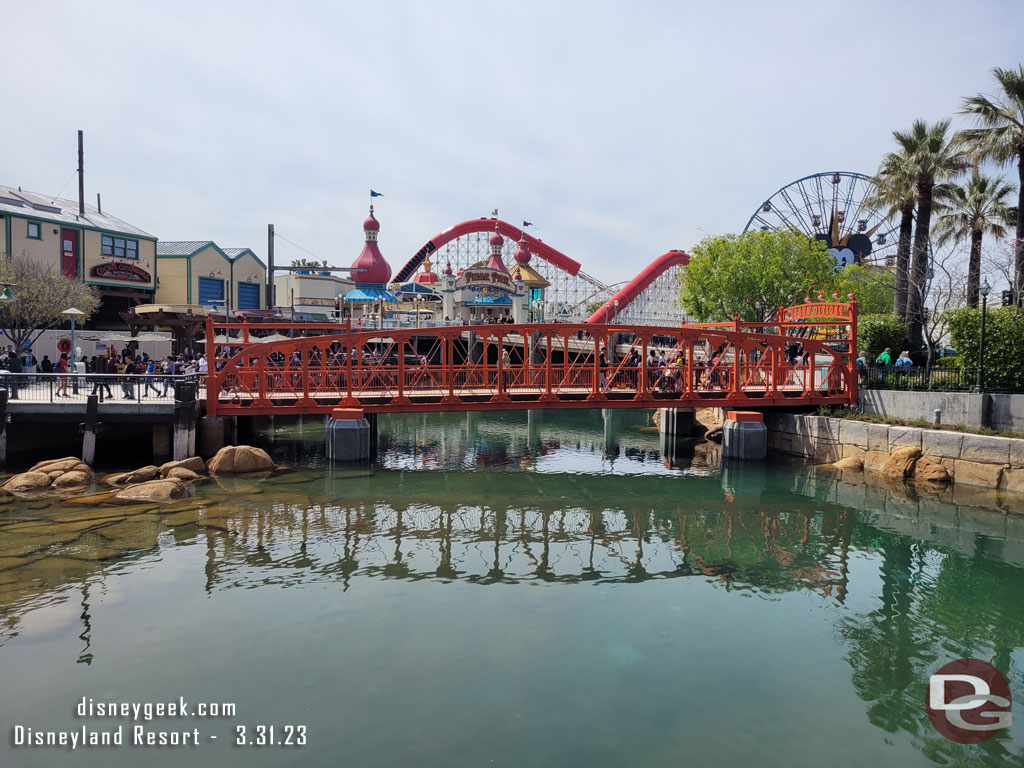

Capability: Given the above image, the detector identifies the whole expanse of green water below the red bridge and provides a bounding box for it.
[0,412,1024,768]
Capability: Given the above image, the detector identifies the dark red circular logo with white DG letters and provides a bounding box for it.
[926,658,1011,744]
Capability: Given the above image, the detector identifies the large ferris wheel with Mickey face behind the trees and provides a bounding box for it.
[743,171,899,268]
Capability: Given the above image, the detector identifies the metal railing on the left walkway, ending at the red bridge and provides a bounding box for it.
[0,371,206,404]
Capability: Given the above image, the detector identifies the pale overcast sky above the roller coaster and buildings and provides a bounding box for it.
[0,0,1024,283]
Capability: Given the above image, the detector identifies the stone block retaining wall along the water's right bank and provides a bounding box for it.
[765,413,1024,493]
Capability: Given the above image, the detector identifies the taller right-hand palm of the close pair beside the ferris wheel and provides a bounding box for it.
[893,120,968,349]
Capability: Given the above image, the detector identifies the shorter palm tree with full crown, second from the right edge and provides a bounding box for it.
[935,170,1016,308]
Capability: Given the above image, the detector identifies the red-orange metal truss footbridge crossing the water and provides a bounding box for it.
[207,302,857,416]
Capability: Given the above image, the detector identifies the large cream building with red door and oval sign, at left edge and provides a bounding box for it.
[0,185,157,326]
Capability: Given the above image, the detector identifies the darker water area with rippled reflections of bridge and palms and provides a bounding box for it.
[0,412,1024,765]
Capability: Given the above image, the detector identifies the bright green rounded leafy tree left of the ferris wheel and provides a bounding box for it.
[680,230,836,322]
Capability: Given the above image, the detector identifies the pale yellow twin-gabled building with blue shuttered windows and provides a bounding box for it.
[155,240,266,311]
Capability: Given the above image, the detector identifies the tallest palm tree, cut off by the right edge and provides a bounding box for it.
[959,65,1024,300]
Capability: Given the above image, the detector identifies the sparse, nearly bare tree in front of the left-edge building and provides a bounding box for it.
[0,256,99,349]
